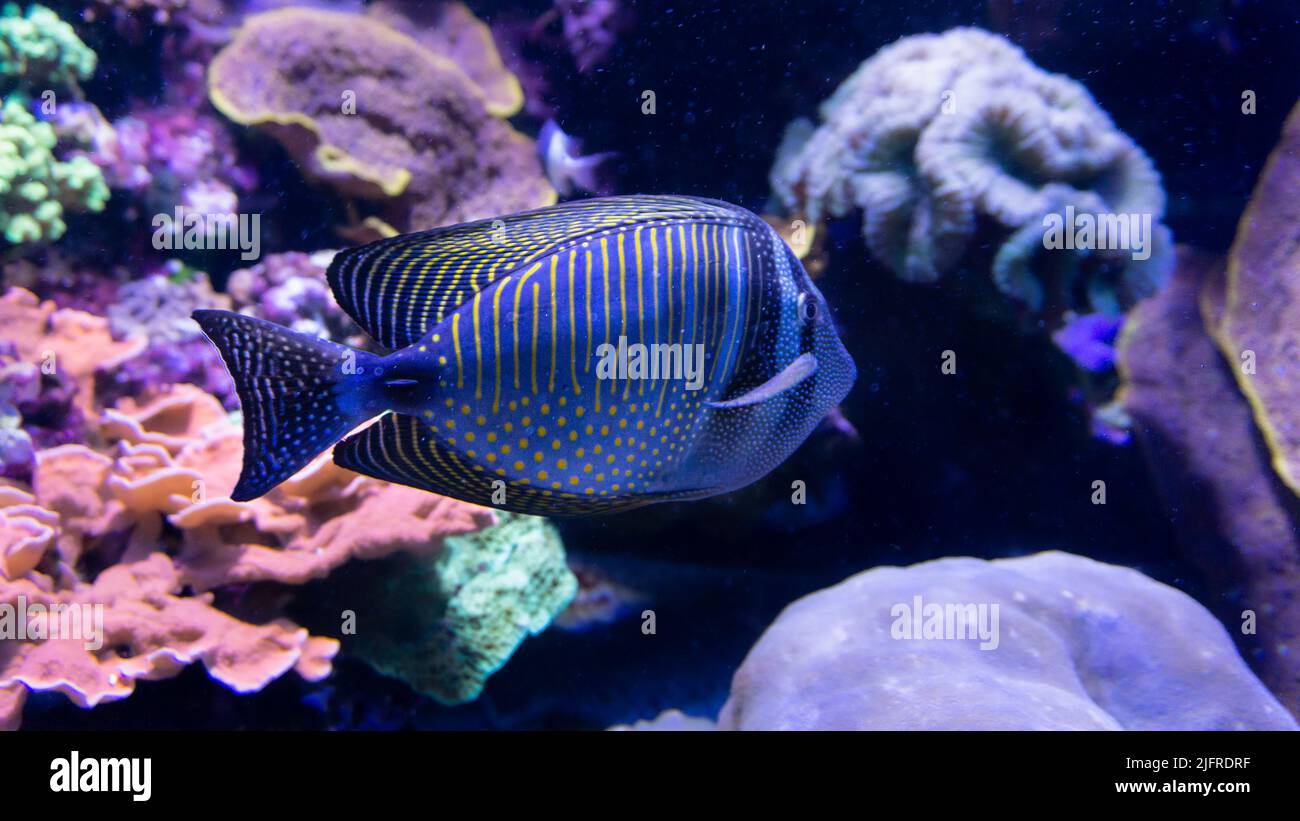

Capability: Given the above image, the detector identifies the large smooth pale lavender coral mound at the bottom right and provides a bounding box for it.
[718,552,1296,730]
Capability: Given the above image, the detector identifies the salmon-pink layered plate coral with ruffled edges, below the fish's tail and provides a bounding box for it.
[0,289,501,726]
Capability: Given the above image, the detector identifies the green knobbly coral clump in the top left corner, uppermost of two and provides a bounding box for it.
[0,3,96,90]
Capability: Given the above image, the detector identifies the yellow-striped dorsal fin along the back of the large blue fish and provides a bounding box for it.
[329,195,746,349]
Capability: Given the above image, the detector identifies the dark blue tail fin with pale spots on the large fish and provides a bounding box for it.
[194,310,384,501]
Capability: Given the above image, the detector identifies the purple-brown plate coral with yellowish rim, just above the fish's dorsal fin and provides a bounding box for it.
[208,9,555,233]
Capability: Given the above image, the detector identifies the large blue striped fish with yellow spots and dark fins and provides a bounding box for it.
[194,196,857,516]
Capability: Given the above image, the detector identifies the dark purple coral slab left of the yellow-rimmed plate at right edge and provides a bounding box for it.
[1118,248,1300,714]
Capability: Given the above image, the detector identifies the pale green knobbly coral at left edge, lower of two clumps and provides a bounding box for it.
[0,97,108,246]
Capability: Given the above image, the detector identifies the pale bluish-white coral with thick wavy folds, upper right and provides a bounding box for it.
[771,29,1171,320]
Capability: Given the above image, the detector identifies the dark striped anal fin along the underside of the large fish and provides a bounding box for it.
[334,413,676,516]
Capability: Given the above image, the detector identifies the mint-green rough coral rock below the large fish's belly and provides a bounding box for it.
[348,512,577,704]
